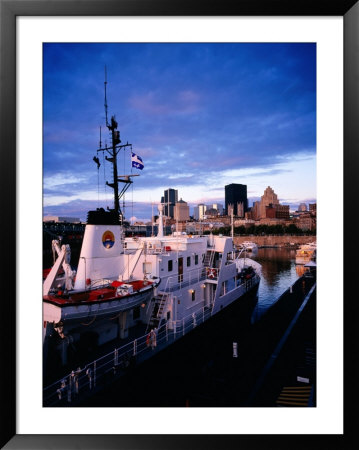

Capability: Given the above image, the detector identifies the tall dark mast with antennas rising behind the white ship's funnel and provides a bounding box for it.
[97,66,134,224]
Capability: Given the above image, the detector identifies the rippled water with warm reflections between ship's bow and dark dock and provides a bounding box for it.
[248,248,305,321]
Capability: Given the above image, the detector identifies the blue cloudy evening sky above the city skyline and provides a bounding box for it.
[43,43,316,222]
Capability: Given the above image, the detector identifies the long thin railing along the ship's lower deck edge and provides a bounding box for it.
[43,305,211,406]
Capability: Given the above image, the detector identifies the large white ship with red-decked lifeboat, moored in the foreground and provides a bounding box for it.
[43,77,261,405]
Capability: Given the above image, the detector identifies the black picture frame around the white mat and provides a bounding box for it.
[0,0,359,450]
